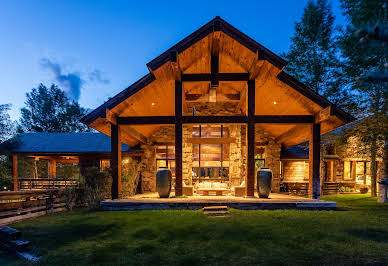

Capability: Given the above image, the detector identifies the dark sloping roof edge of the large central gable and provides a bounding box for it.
[81,16,354,125]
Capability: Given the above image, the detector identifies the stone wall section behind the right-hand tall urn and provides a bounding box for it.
[255,126,281,192]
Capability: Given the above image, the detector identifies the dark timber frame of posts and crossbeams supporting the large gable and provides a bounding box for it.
[111,51,320,199]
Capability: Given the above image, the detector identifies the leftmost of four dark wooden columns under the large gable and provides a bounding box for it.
[110,124,121,199]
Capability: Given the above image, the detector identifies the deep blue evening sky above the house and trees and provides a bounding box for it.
[0,0,344,119]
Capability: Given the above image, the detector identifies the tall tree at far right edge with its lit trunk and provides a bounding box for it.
[338,0,388,196]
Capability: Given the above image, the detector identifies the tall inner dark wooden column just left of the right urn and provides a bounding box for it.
[247,80,256,197]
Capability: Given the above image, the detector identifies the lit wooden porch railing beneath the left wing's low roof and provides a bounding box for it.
[19,178,79,190]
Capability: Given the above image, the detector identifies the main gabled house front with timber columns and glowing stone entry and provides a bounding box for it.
[78,17,354,199]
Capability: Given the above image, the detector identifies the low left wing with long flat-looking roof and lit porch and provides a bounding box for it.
[0,132,141,190]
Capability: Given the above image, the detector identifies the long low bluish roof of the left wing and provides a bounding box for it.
[0,132,131,154]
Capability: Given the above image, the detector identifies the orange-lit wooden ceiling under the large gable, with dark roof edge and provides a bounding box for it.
[83,18,352,146]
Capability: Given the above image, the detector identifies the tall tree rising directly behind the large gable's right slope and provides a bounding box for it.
[284,0,355,112]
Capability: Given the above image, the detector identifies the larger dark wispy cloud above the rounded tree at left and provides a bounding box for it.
[39,58,84,101]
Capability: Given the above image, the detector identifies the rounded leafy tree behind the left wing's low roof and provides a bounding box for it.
[18,84,90,132]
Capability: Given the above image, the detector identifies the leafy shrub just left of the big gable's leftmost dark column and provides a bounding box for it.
[83,167,112,210]
